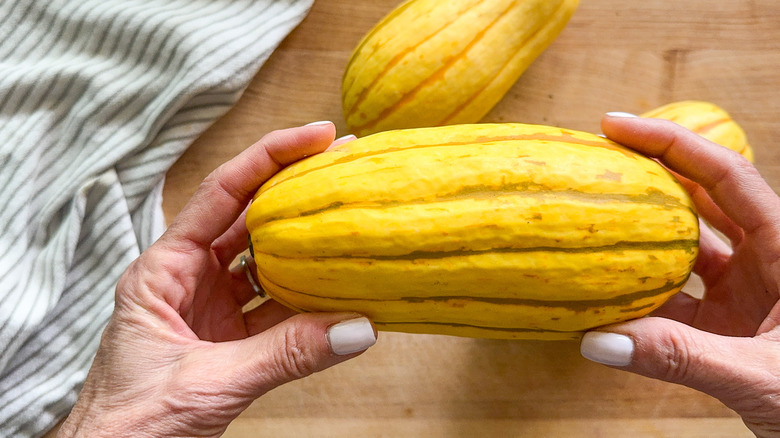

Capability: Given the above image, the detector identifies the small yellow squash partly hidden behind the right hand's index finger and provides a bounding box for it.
[642,100,753,162]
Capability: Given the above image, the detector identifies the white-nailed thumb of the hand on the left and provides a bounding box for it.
[216,313,376,397]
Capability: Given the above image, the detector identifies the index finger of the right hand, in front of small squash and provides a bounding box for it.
[601,115,780,233]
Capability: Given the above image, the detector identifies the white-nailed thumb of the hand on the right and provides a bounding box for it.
[580,317,755,404]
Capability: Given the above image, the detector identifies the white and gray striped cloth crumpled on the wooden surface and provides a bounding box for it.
[0,0,313,437]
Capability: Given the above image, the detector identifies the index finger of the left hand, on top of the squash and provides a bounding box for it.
[163,122,336,249]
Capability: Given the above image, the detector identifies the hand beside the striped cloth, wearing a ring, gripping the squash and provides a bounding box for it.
[60,122,376,437]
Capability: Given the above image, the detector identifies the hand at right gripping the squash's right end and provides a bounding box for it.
[581,115,780,437]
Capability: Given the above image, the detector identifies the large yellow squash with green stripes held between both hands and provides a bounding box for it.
[246,124,698,339]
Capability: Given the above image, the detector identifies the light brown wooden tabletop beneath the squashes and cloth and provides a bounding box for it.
[50,0,780,438]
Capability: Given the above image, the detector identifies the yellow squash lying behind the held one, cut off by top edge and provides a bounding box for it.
[342,0,579,136]
